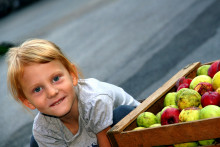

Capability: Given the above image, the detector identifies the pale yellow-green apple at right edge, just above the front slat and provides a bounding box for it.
[199,105,220,119]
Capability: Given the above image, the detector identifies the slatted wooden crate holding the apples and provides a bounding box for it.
[107,61,220,147]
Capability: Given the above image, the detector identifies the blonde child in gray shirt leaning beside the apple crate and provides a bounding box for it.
[7,39,139,147]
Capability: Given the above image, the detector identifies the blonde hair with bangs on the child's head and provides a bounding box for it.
[7,39,81,102]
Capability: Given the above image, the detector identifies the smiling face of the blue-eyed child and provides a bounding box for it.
[20,60,77,117]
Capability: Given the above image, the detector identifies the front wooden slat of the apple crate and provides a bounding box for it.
[113,118,220,147]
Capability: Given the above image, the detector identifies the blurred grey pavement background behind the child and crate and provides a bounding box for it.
[0,0,220,147]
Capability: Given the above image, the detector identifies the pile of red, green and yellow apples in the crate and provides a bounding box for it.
[134,60,220,147]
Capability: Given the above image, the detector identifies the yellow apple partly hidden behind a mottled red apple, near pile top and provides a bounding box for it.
[189,75,212,89]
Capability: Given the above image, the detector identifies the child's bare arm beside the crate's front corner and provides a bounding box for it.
[96,127,111,147]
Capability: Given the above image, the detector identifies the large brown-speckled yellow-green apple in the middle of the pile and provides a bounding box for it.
[176,89,201,110]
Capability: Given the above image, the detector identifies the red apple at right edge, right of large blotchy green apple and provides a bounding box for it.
[201,91,220,107]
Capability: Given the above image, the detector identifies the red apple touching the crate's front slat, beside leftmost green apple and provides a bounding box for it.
[161,108,180,125]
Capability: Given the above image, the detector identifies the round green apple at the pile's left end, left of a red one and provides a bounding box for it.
[137,112,158,128]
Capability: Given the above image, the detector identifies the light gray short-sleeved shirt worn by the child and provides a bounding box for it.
[33,79,139,147]
